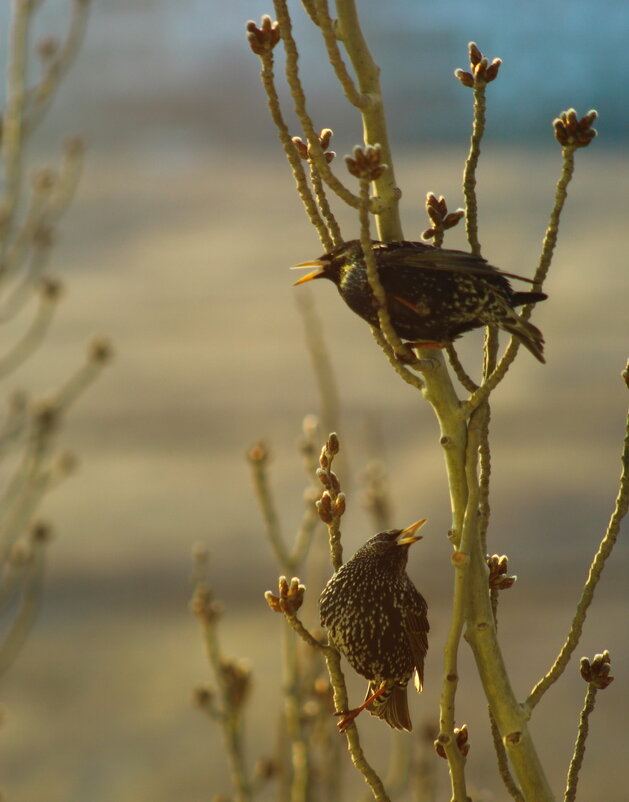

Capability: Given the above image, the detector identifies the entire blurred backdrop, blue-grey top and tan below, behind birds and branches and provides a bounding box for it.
[0,0,629,802]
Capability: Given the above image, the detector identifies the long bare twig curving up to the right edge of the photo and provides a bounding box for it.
[524,404,629,715]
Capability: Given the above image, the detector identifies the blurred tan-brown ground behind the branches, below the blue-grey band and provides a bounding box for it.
[0,147,629,802]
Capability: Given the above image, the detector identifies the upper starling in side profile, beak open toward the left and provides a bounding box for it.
[295,240,547,362]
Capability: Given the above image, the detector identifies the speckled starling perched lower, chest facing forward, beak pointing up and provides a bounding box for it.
[319,518,429,732]
